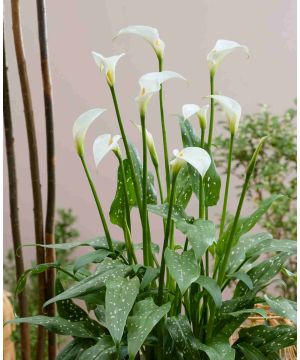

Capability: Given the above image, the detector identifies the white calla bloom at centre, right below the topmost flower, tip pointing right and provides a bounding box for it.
[135,71,185,114]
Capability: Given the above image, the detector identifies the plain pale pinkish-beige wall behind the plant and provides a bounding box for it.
[4,0,296,260]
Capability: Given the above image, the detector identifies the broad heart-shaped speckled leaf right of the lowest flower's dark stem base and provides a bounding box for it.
[165,248,200,295]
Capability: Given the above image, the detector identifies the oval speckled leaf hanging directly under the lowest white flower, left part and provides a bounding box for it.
[175,164,193,209]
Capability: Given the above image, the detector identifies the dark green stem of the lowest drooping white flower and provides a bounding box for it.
[157,173,178,305]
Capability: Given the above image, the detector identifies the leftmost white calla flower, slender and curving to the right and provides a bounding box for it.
[73,109,106,156]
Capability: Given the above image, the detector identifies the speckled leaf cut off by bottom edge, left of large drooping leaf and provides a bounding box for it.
[78,335,117,360]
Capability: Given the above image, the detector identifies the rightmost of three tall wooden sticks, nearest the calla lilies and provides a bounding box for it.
[36,0,56,360]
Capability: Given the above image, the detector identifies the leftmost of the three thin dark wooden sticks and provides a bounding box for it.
[3,35,31,360]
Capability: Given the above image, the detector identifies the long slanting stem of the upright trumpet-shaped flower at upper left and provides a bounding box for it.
[109,86,143,221]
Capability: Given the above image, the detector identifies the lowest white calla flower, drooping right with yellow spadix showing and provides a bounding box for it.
[170,147,211,177]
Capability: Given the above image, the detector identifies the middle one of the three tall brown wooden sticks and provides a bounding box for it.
[11,0,46,360]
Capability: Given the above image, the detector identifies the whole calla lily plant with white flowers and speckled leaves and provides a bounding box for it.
[12,26,296,360]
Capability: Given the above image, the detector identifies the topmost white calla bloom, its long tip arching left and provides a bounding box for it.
[116,25,165,59]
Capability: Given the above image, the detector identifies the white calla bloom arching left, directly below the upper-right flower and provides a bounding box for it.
[208,95,242,135]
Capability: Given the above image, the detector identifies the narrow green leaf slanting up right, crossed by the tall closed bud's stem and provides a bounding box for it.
[217,195,282,256]
